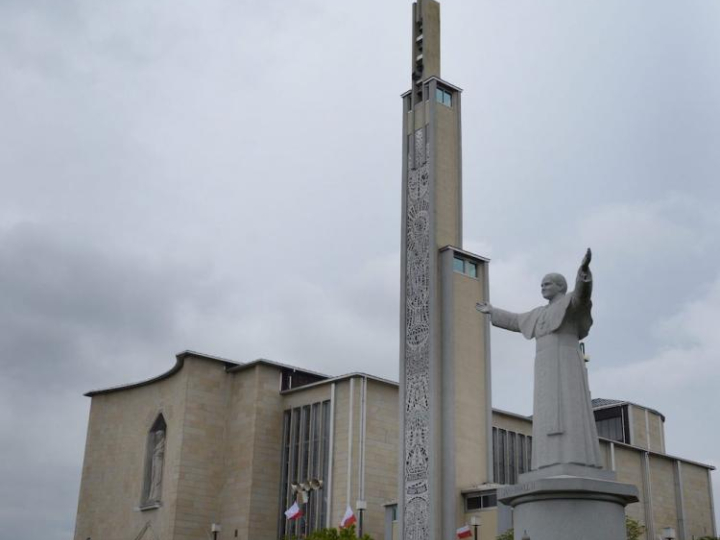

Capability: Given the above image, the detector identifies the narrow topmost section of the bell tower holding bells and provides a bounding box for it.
[411,0,440,90]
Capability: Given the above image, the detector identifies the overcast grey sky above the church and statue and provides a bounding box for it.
[0,0,720,540]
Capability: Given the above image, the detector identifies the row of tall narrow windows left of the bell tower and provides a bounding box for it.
[278,401,330,538]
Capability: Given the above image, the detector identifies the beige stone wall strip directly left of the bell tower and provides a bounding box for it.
[360,380,399,540]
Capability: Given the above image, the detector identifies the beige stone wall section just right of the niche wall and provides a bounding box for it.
[172,357,229,540]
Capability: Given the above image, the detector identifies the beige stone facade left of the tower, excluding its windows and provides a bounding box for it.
[75,353,398,540]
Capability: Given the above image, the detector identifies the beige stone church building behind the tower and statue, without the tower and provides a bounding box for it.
[75,351,716,540]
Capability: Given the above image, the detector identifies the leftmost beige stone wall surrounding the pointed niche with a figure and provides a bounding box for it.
[75,362,187,540]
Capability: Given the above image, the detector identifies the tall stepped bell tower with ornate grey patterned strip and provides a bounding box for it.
[398,0,492,540]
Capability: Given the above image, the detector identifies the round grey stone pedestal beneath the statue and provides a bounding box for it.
[498,468,638,540]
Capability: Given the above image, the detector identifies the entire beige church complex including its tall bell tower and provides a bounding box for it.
[75,0,717,540]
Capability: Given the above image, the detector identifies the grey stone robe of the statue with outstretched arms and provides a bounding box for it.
[491,272,602,469]
